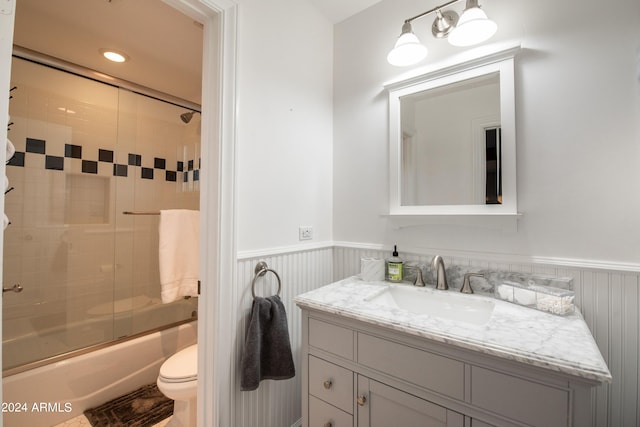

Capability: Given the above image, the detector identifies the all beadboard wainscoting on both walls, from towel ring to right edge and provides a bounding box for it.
[230,244,640,427]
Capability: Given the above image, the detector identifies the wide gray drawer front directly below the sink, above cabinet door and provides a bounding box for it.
[358,333,464,400]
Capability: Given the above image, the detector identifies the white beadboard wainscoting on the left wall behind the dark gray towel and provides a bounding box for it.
[231,245,333,427]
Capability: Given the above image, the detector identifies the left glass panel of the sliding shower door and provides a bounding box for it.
[3,58,118,369]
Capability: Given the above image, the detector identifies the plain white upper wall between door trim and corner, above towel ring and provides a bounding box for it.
[236,0,333,251]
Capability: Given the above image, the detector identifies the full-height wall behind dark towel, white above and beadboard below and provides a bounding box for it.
[225,0,333,427]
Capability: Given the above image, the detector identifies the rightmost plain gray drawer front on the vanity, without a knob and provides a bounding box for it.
[471,366,569,427]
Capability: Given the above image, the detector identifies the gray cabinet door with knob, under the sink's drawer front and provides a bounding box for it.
[356,375,464,427]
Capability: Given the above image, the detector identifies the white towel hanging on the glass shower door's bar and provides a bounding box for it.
[159,209,200,304]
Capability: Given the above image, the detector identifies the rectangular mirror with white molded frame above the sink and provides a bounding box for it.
[385,46,520,216]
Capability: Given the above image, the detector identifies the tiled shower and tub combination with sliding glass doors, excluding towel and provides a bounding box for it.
[2,48,200,427]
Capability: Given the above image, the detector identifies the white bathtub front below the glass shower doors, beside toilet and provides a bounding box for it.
[2,322,197,427]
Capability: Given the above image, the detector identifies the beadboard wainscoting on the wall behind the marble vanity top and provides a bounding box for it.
[333,244,640,427]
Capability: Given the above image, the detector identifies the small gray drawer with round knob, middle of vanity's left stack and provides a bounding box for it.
[309,356,353,414]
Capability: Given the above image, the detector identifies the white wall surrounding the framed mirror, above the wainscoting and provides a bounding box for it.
[333,0,640,269]
